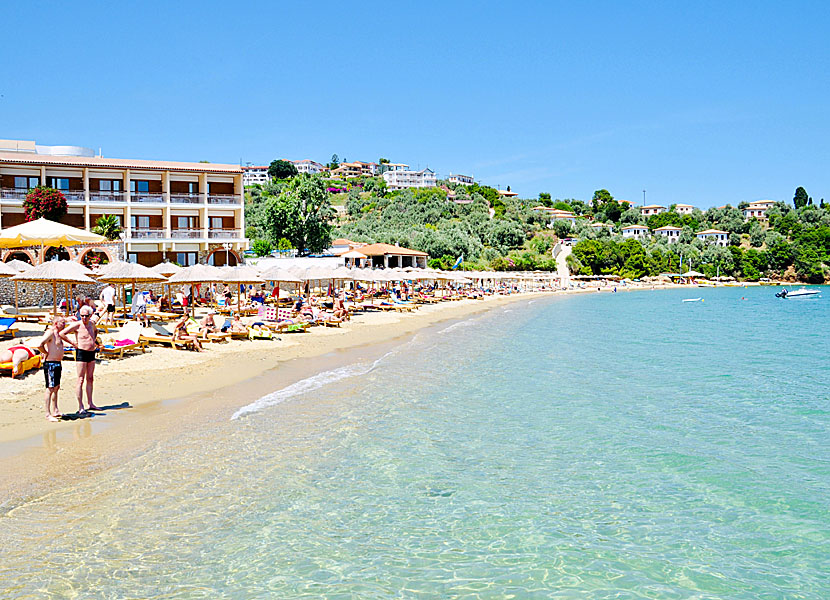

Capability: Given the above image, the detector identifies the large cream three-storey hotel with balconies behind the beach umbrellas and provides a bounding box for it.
[0,140,248,266]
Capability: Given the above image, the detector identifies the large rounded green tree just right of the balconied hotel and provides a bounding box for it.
[265,174,334,254]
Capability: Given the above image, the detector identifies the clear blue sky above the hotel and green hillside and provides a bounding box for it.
[0,2,830,207]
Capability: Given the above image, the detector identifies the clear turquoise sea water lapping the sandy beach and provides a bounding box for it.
[0,288,830,599]
